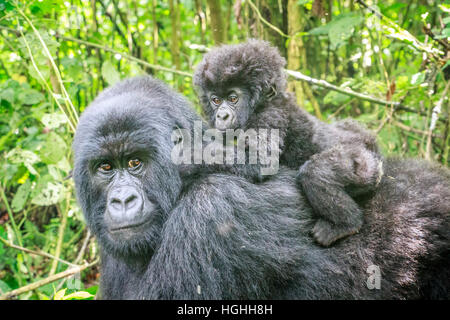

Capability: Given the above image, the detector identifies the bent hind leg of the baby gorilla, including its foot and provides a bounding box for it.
[297,144,382,246]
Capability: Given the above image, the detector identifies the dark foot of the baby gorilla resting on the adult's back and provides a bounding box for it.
[312,219,361,247]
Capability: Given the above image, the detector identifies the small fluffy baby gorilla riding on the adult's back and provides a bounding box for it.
[194,40,382,246]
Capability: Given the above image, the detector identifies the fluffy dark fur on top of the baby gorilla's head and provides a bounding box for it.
[194,39,286,116]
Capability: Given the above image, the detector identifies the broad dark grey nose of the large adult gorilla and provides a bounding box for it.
[107,186,144,225]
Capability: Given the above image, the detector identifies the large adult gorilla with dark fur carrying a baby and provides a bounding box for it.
[74,77,450,299]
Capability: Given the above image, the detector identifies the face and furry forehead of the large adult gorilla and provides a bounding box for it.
[74,95,181,255]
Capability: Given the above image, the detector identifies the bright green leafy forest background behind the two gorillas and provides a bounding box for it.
[0,0,450,299]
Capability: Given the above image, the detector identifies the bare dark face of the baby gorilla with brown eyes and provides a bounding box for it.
[209,87,251,131]
